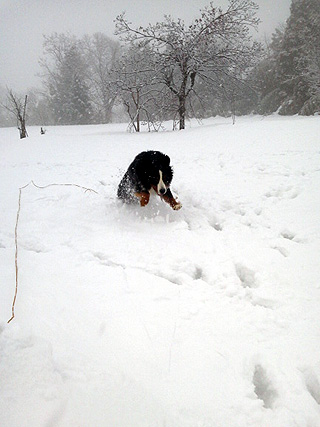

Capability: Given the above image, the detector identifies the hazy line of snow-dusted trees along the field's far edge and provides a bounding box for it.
[0,0,320,131]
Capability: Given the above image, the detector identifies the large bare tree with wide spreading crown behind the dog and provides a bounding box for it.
[116,0,260,129]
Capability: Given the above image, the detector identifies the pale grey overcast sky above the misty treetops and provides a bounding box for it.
[0,0,291,91]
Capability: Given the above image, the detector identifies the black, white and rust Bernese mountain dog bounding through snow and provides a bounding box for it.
[118,151,182,210]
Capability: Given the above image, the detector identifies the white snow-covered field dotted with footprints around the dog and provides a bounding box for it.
[0,116,320,427]
